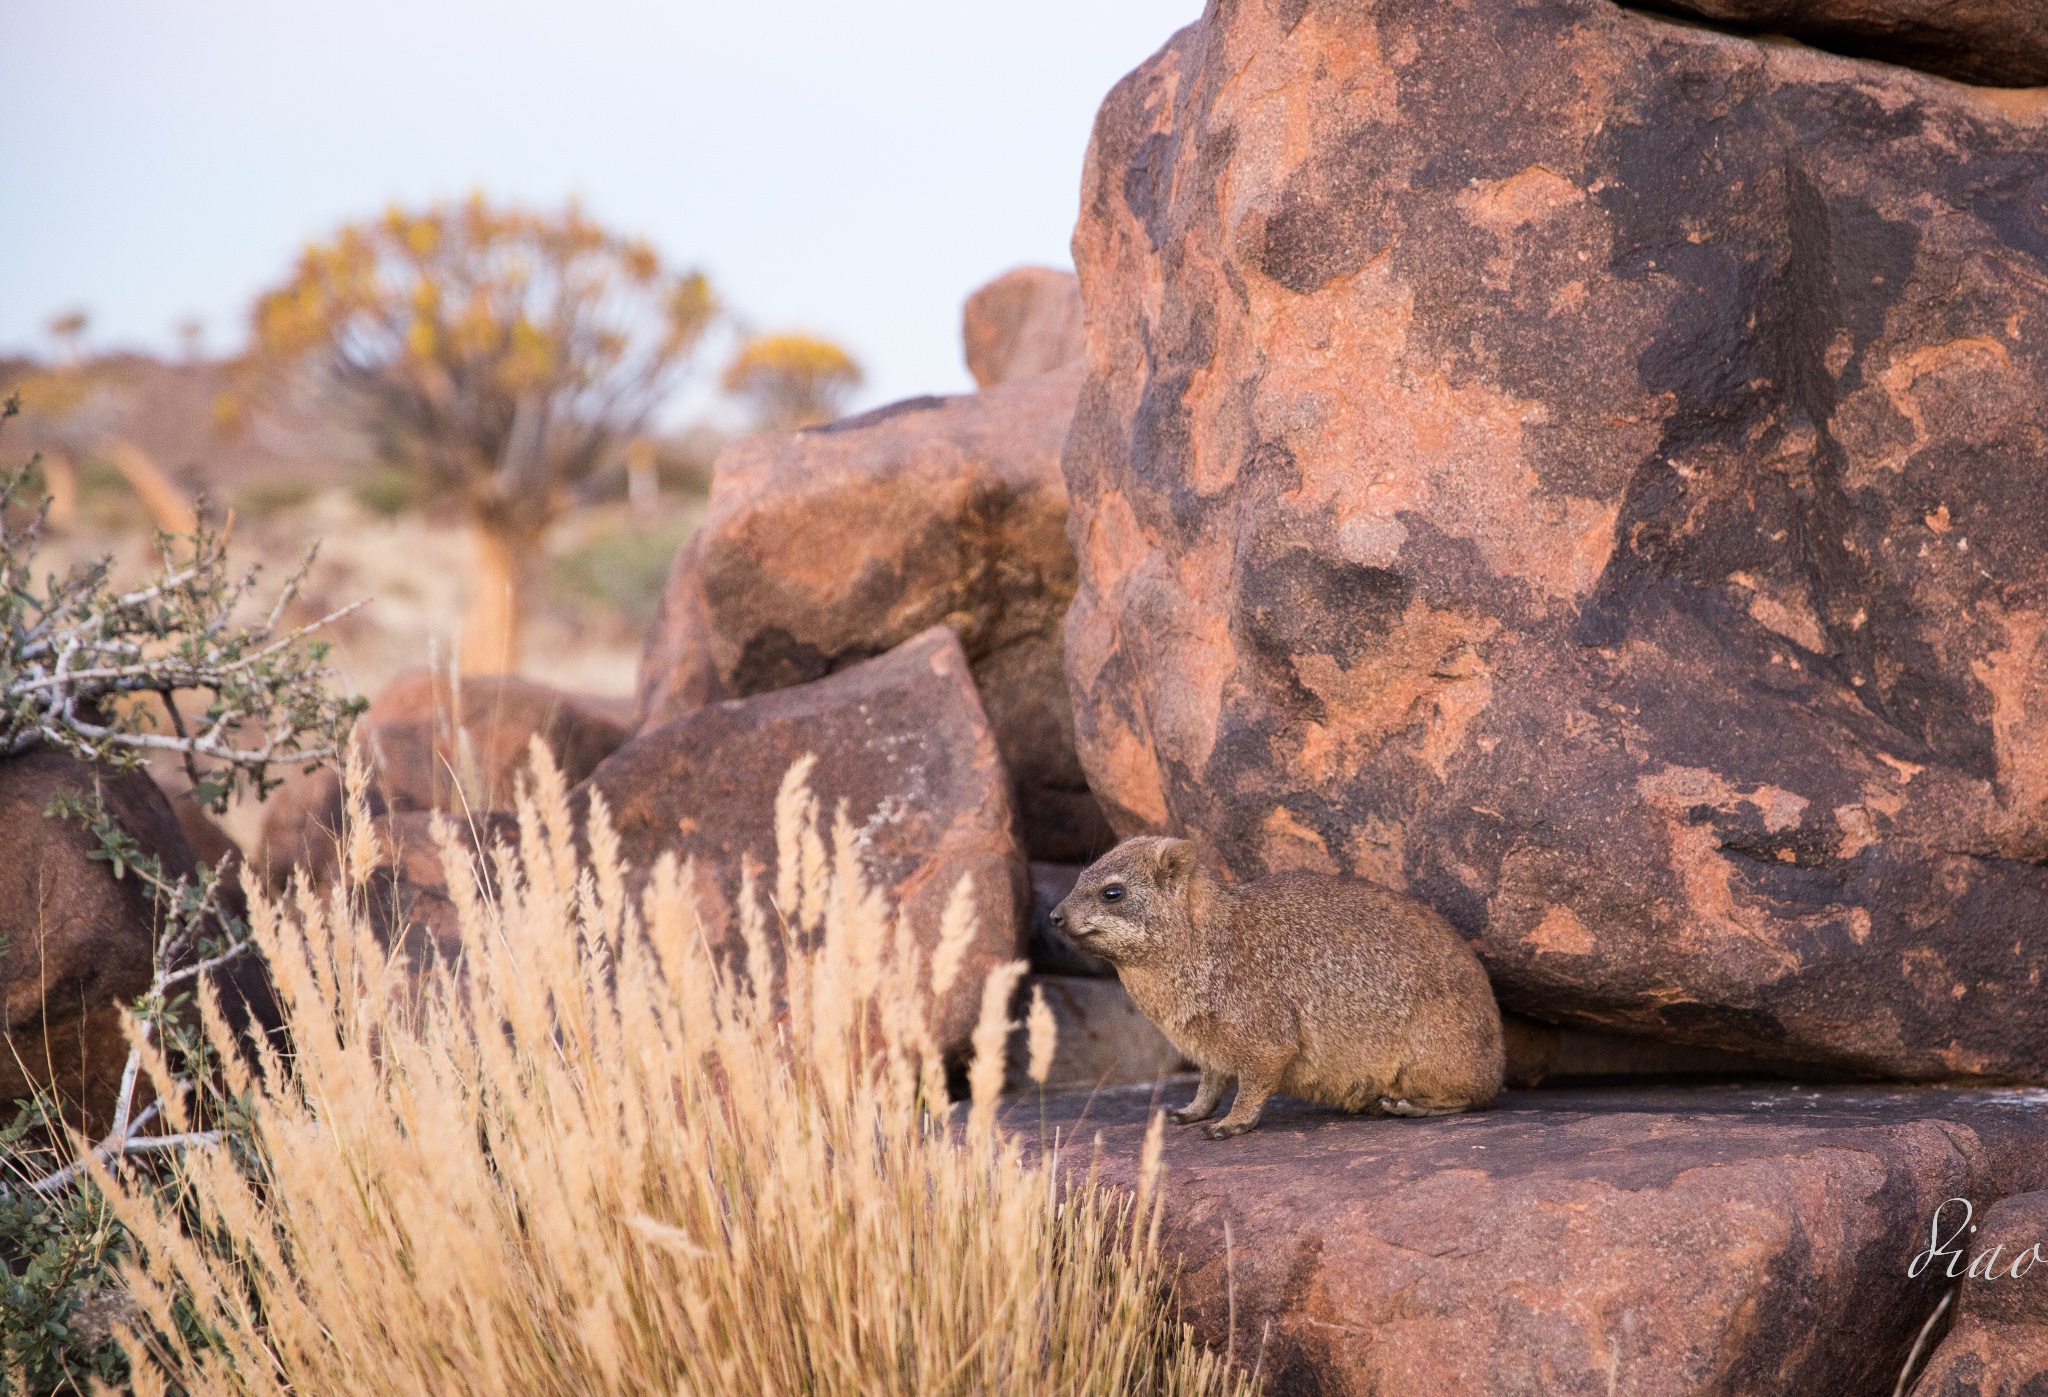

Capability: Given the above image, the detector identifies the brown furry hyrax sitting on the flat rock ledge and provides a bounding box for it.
[1053,838,1501,1139]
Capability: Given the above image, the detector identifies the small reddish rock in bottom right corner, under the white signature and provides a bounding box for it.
[1913,1192,2048,1397]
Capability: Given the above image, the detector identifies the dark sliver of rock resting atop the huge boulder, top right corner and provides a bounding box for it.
[1647,0,2048,88]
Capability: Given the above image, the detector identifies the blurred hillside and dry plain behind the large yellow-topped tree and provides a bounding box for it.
[0,317,729,708]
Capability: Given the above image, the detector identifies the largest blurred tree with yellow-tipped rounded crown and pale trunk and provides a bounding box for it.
[252,195,717,674]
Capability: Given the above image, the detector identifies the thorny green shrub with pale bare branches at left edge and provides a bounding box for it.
[0,399,360,1395]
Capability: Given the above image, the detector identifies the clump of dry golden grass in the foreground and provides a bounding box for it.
[100,746,1253,1397]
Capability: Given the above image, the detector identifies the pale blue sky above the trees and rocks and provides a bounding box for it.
[0,0,1200,404]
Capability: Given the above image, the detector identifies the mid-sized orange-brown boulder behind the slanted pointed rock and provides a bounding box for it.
[641,371,1114,860]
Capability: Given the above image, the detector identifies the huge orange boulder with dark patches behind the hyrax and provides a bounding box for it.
[1065,0,2048,1080]
